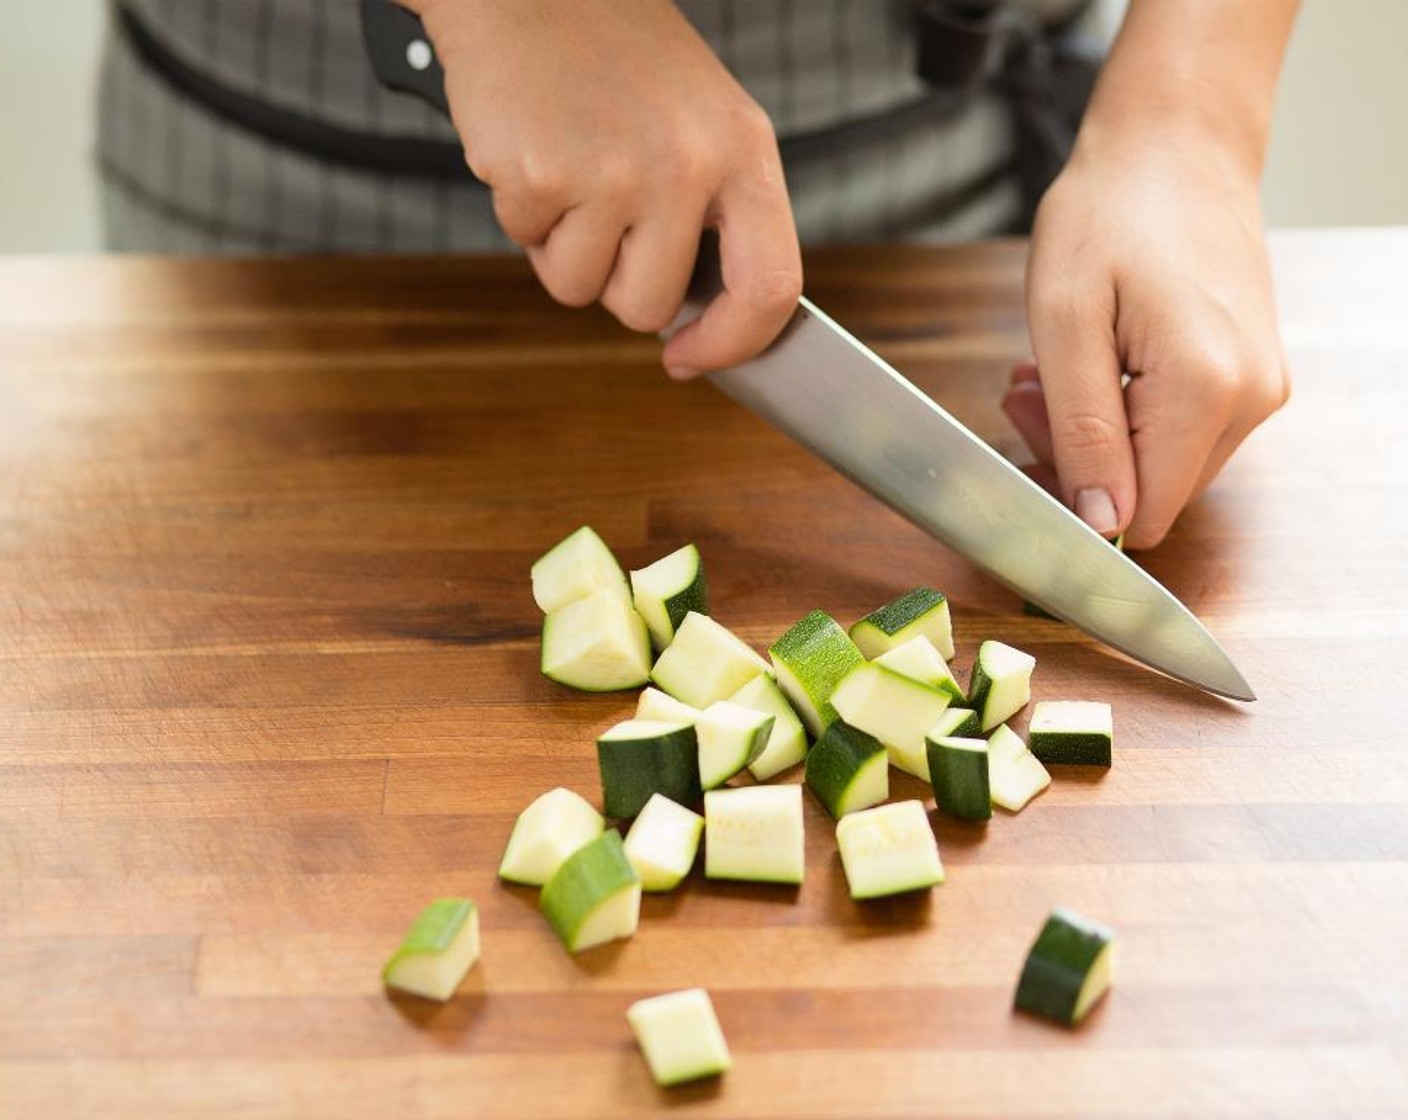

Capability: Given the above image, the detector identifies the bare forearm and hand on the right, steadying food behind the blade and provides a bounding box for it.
[1004,0,1297,548]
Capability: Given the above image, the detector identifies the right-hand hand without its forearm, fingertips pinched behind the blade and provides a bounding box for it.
[1002,132,1290,548]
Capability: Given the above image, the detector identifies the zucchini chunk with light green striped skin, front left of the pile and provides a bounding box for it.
[538,828,641,952]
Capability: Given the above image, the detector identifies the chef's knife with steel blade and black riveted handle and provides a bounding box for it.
[362,0,1256,700]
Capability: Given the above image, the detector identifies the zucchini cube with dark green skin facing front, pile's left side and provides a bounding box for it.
[597,720,704,819]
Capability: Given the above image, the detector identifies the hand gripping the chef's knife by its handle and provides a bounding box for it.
[417,0,801,376]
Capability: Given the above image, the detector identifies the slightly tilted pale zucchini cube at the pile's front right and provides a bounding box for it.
[836,802,943,899]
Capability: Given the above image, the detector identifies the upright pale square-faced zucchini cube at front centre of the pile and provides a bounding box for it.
[704,785,805,883]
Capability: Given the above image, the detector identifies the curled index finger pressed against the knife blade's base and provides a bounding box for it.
[665,169,801,378]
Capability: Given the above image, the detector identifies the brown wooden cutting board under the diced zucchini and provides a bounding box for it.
[0,231,1408,1120]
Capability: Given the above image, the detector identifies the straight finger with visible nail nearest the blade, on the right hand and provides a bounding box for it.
[1031,293,1138,537]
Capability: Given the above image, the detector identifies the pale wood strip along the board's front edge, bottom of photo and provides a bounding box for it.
[0,1053,1408,1120]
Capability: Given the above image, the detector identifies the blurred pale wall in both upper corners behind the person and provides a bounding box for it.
[0,0,1408,252]
